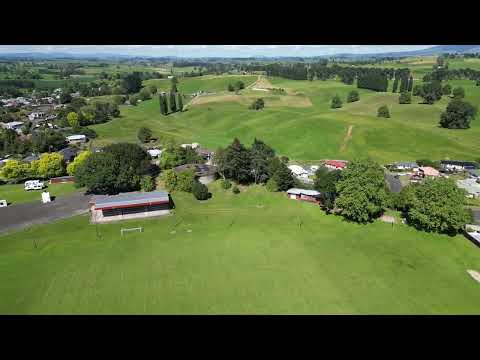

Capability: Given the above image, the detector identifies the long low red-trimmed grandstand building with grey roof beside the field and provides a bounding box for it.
[90,191,173,223]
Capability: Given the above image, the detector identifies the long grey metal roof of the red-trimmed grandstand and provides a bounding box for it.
[90,191,170,209]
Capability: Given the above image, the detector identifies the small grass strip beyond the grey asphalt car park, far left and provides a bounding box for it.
[0,183,80,205]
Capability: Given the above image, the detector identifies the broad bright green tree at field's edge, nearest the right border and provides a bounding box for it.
[407,178,470,234]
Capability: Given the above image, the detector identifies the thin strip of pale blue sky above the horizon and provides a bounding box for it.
[0,45,433,57]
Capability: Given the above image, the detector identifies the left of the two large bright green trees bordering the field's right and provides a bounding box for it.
[335,159,388,223]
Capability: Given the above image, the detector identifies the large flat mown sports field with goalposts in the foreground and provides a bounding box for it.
[0,184,480,314]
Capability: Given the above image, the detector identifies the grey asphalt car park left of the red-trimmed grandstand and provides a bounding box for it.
[0,193,90,234]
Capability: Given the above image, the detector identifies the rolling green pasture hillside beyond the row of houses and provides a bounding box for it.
[93,76,480,163]
